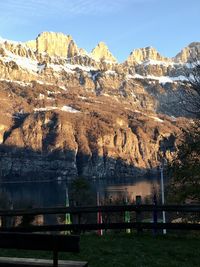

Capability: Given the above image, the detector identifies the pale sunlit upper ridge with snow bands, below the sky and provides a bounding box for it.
[0,32,200,92]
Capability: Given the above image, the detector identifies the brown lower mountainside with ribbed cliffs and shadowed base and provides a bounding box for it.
[0,79,184,179]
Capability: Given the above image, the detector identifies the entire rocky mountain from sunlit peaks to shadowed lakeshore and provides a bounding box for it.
[0,32,199,179]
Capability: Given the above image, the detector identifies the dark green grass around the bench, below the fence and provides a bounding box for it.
[0,233,200,267]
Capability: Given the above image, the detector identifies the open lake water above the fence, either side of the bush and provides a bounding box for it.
[0,176,160,209]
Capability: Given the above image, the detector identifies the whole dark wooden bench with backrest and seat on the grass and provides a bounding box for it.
[0,232,88,267]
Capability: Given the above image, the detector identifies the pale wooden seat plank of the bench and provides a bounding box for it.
[0,257,88,267]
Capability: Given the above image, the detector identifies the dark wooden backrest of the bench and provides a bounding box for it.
[0,232,80,252]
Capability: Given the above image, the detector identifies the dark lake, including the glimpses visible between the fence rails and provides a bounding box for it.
[0,176,163,226]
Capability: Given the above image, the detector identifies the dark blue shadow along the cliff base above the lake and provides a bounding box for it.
[0,145,156,181]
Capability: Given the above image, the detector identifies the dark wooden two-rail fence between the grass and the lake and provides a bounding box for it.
[0,205,200,232]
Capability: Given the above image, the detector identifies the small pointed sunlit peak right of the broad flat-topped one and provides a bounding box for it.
[91,42,117,63]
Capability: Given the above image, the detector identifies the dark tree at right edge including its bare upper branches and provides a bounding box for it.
[168,56,200,203]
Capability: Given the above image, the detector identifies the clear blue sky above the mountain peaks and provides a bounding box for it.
[0,0,200,61]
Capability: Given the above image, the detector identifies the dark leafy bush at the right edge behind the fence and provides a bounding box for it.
[168,124,200,203]
